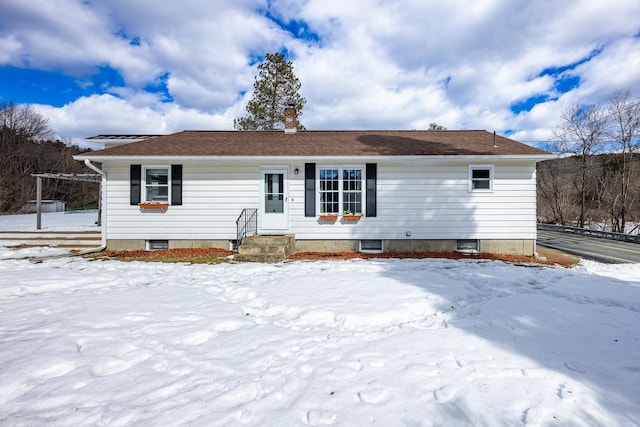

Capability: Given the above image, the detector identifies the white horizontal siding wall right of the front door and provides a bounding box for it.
[289,161,536,239]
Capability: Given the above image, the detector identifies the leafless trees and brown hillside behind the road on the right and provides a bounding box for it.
[537,90,640,233]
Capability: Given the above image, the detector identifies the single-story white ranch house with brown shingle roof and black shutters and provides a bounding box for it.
[75,110,552,255]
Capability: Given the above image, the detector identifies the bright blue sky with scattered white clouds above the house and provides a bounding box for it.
[0,0,640,145]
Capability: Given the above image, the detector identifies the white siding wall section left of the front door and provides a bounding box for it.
[103,162,260,240]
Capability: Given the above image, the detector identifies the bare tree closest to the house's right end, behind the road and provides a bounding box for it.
[554,105,607,227]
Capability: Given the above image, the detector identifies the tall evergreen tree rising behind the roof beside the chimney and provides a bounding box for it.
[233,53,307,130]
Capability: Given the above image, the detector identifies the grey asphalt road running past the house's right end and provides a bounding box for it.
[537,229,640,264]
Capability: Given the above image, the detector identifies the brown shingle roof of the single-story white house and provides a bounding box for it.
[83,130,549,157]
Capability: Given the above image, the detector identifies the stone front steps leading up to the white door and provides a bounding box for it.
[233,234,295,263]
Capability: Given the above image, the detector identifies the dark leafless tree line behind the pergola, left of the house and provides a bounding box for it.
[0,102,99,213]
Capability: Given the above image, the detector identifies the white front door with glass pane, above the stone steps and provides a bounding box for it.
[259,168,289,231]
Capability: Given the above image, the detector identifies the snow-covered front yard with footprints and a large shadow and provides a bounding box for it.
[0,212,640,426]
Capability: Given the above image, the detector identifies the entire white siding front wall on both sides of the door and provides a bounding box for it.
[103,159,536,244]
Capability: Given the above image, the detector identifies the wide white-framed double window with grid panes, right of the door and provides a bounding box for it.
[318,167,363,215]
